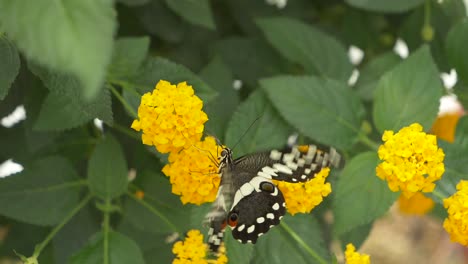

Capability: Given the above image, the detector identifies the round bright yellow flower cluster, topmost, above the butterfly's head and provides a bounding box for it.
[132,80,208,153]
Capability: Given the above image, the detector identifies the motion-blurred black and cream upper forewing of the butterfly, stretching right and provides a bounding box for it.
[234,145,340,183]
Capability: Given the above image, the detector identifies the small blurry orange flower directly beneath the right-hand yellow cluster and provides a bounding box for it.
[398,192,434,215]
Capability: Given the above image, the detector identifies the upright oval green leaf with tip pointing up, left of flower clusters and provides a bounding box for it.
[88,134,128,199]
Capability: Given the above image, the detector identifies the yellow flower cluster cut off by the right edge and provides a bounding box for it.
[444,181,468,246]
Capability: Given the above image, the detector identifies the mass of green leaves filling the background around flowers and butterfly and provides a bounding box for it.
[0,0,468,264]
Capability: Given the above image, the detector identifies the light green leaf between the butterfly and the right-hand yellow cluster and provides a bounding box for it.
[333,152,399,235]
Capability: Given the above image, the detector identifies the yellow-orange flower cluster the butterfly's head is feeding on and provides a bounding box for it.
[162,137,221,205]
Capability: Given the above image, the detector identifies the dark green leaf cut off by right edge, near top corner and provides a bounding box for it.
[445,19,468,84]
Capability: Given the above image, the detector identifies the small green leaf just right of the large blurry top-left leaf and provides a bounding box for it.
[108,37,150,80]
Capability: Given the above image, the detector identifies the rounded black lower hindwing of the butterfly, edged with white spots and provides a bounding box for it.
[227,181,286,243]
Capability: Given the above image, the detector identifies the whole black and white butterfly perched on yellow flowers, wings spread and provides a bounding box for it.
[205,145,340,252]
